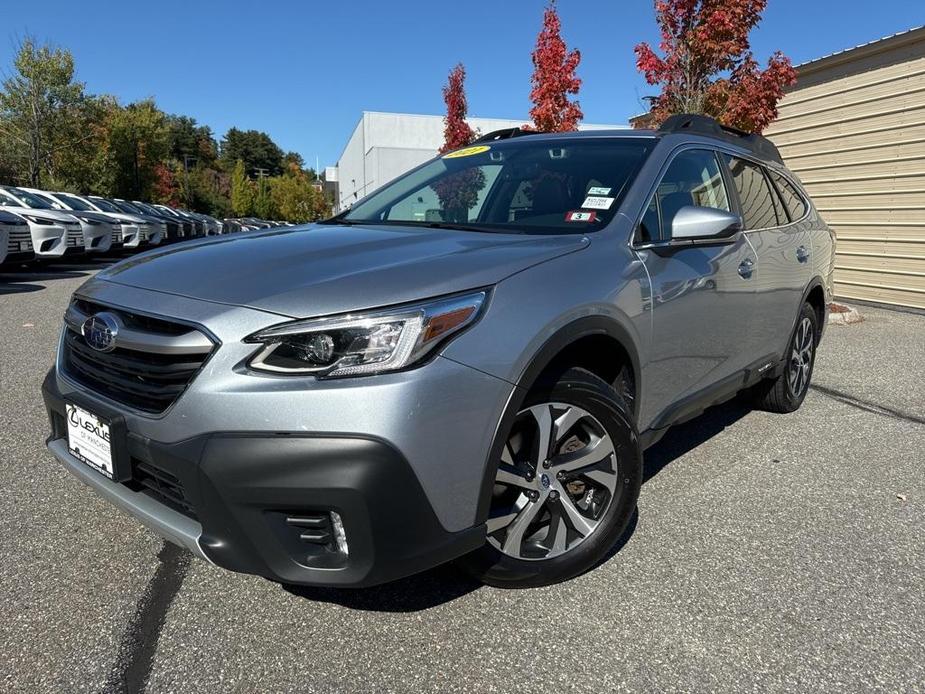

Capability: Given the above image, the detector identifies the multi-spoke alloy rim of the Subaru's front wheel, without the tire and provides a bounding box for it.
[487,402,619,561]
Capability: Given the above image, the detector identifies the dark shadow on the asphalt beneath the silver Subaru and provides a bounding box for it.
[282,394,753,612]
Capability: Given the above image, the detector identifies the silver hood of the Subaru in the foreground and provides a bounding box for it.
[97,225,590,318]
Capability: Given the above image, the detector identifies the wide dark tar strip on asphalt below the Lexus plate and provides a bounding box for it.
[103,542,190,694]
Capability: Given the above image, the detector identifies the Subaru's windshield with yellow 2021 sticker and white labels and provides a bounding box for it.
[331,136,654,234]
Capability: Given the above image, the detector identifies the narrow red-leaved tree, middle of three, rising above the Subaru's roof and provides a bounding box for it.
[530,0,584,132]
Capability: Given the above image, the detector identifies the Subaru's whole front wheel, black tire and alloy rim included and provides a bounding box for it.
[460,369,642,588]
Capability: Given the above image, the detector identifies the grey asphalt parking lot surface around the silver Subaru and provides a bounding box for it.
[0,264,925,692]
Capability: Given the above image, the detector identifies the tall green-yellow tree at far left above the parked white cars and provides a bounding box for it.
[0,37,84,187]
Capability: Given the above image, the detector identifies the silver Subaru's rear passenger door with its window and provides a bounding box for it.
[724,154,812,359]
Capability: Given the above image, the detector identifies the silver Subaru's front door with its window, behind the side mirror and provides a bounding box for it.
[635,148,758,427]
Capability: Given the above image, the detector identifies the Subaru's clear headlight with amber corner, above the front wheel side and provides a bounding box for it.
[246,291,488,378]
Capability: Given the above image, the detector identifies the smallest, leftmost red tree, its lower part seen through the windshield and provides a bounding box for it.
[433,63,485,222]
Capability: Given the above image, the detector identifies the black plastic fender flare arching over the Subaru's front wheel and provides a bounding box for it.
[475,316,642,524]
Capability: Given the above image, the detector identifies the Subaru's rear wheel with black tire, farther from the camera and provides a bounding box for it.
[754,303,819,414]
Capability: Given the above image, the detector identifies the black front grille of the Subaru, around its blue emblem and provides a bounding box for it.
[61,301,209,414]
